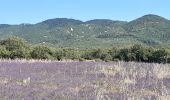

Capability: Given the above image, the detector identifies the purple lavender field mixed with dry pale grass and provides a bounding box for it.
[0,61,170,100]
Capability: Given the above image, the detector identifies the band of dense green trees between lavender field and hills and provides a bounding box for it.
[0,37,170,63]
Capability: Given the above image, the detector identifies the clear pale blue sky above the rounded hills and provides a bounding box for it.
[0,0,170,24]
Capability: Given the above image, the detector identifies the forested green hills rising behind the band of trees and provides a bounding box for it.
[0,14,170,48]
